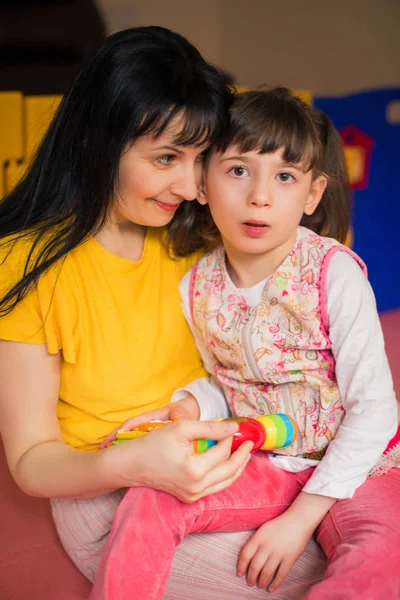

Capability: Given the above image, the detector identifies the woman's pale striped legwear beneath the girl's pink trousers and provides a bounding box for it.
[51,490,326,600]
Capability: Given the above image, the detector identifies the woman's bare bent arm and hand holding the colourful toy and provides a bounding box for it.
[0,340,252,502]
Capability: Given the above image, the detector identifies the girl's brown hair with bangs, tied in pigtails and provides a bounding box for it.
[175,87,351,253]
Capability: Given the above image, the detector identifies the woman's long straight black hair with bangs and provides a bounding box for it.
[0,27,231,315]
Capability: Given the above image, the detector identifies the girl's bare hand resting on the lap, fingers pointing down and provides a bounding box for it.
[237,512,313,592]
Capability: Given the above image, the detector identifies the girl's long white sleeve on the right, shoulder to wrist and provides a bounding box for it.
[304,252,398,498]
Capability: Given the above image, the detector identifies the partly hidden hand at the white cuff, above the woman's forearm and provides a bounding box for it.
[99,394,200,449]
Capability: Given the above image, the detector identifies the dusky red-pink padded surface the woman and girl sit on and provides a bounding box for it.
[0,310,400,600]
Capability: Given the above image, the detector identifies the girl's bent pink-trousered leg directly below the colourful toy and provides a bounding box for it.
[91,455,312,600]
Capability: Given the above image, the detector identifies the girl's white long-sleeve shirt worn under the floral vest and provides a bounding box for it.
[172,252,397,498]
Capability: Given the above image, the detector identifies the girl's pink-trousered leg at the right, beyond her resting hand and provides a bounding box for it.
[305,468,400,600]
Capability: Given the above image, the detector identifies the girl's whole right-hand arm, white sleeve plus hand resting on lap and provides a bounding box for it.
[238,252,397,592]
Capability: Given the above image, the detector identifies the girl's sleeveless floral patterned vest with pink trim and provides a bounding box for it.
[190,227,366,456]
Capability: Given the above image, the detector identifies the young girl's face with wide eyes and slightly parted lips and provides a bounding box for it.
[198,147,326,260]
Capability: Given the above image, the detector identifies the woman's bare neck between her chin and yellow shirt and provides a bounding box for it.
[94,219,146,262]
